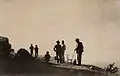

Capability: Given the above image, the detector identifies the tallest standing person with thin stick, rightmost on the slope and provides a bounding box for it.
[75,38,84,66]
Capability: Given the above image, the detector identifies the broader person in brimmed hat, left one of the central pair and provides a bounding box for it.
[53,41,62,63]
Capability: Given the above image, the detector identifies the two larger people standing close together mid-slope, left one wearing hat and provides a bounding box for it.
[54,40,66,63]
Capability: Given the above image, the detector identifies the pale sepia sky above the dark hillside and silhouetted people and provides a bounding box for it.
[0,0,120,65]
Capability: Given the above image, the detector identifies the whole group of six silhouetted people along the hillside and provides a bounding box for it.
[29,38,84,66]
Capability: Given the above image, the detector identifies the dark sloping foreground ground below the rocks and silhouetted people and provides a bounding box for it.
[0,58,118,76]
